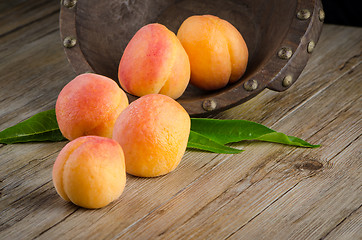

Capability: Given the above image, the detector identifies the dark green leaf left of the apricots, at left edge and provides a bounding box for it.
[0,109,66,144]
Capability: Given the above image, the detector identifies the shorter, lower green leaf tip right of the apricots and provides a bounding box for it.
[187,131,243,154]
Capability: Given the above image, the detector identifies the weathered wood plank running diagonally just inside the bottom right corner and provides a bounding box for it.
[230,138,362,239]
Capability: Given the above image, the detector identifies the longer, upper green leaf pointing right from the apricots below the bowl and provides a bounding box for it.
[191,118,319,148]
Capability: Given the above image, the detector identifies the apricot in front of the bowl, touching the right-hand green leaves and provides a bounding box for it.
[113,94,190,177]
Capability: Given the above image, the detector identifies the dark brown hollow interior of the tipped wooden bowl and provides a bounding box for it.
[76,0,297,100]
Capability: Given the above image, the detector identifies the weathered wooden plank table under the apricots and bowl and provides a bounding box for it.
[0,0,362,239]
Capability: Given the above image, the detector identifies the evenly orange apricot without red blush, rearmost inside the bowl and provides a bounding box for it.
[177,15,248,90]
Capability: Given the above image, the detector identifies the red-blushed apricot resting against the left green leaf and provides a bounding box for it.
[55,73,128,140]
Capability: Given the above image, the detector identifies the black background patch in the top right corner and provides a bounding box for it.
[322,0,362,27]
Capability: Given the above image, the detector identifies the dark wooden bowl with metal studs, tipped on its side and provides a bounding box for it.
[60,0,324,116]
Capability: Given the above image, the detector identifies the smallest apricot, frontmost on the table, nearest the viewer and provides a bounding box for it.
[53,136,126,208]
